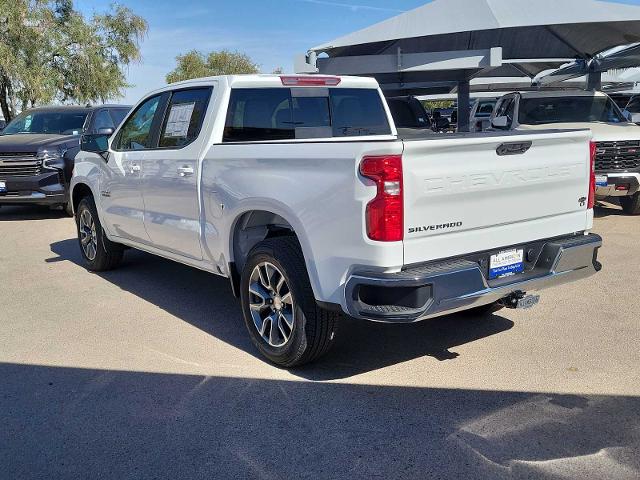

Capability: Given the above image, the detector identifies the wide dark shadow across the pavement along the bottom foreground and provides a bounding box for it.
[0,363,640,480]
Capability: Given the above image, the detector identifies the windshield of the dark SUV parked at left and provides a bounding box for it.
[2,111,87,135]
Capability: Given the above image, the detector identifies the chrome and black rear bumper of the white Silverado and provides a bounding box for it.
[344,234,602,323]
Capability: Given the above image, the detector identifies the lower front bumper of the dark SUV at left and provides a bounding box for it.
[0,170,68,205]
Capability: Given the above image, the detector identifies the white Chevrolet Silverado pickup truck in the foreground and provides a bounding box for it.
[71,75,602,367]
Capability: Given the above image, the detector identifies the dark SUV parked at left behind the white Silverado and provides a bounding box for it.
[0,105,131,213]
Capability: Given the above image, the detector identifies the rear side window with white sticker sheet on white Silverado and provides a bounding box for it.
[160,88,211,148]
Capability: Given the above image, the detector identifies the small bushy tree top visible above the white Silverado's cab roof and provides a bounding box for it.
[167,50,260,83]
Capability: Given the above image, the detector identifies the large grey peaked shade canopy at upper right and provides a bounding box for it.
[296,0,640,130]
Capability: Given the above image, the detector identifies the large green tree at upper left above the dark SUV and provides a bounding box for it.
[0,0,147,120]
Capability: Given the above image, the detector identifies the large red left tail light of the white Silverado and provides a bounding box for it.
[360,155,404,242]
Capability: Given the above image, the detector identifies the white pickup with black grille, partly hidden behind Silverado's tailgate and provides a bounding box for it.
[491,91,640,215]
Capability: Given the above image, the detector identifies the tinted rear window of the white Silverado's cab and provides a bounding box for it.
[223,88,391,142]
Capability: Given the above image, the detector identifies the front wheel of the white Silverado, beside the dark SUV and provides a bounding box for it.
[76,197,124,272]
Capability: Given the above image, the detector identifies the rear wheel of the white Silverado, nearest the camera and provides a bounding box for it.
[240,237,339,368]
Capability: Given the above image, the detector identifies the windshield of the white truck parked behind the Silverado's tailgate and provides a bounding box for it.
[518,97,626,125]
